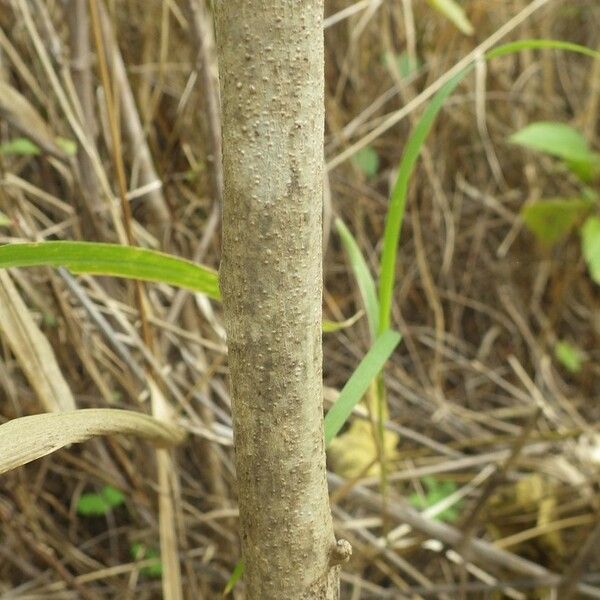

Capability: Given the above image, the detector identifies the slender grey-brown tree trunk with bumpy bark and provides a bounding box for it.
[215,0,345,600]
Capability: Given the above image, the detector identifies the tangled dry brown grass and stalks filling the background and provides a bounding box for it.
[0,0,600,599]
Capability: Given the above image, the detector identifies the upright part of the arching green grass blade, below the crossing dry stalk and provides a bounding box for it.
[379,69,468,333]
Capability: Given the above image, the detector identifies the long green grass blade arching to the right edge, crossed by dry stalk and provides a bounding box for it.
[379,39,600,333]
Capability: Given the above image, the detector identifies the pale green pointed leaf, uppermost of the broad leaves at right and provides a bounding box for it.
[509,121,600,166]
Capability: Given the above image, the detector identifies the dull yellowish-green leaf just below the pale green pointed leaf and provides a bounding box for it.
[521,198,594,245]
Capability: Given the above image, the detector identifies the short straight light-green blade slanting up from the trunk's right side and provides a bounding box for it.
[325,329,402,445]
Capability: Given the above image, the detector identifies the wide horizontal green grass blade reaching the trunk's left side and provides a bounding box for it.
[0,242,220,300]
